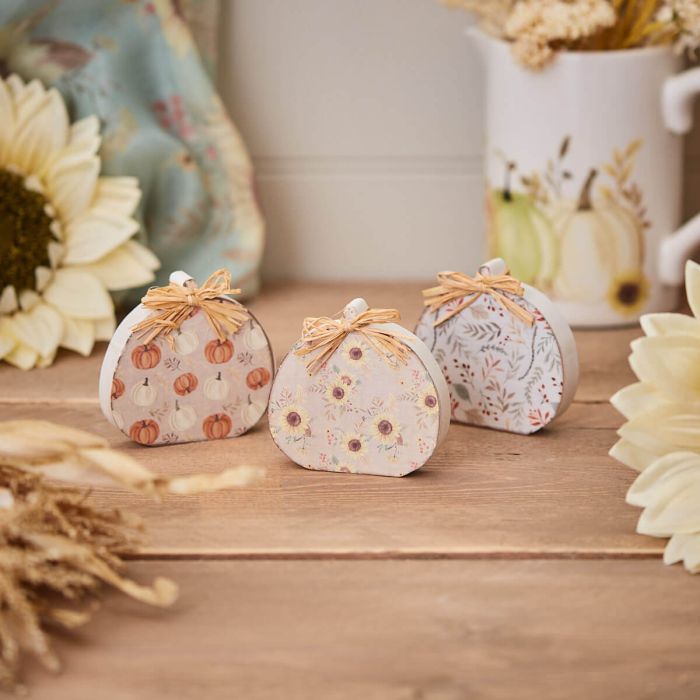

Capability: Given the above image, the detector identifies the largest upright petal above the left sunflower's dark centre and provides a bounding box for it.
[6,89,68,174]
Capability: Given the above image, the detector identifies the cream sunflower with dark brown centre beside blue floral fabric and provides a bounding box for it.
[0,75,158,369]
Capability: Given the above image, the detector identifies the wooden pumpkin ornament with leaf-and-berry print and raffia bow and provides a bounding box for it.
[415,258,578,434]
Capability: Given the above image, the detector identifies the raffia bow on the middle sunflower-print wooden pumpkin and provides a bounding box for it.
[295,309,409,374]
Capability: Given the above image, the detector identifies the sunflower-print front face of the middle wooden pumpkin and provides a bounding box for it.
[268,333,439,476]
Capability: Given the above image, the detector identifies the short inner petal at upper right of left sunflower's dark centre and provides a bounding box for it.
[46,156,100,224]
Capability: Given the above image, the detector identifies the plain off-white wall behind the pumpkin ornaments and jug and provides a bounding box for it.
[220,0,700,280]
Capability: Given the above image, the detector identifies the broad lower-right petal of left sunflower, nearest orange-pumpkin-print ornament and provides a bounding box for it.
[44,268,114,319]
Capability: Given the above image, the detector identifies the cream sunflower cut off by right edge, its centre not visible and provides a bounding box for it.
[610,261,700,573]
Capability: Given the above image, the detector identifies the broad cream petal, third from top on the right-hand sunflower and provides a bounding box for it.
[630,336,700,401]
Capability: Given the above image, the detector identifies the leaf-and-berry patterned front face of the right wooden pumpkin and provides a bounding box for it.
[415,295,563,434]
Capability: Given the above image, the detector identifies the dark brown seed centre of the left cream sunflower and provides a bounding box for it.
[0,168,56,294]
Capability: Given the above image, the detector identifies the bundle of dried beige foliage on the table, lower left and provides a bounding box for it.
[0,421,262,690]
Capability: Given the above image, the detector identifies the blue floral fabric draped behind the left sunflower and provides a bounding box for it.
[0,0,264,300]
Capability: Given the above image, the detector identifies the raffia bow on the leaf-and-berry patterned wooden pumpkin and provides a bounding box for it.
[423,272,535,327]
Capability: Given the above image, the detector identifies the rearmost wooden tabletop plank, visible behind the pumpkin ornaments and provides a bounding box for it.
[0,282,641,402]
